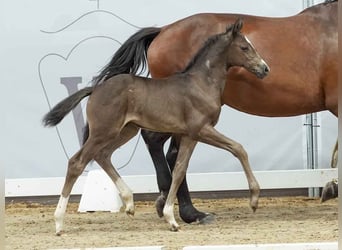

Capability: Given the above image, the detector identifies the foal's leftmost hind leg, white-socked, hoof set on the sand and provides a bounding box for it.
[54,140,100,236]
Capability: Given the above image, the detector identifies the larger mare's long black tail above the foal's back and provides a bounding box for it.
[94,27,161,84]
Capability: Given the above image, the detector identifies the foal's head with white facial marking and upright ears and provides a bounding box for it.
[224,19,270,78]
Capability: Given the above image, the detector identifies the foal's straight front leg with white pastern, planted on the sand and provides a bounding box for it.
[163,136,197,231]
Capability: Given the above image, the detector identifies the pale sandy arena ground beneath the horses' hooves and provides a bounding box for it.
[5,197,338,250]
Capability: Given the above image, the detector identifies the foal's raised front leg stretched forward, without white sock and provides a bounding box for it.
[198,125,260,211]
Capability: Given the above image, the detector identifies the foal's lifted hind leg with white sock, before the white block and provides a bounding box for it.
[94,124,139,216]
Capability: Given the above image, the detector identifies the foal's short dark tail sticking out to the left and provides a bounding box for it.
[43,87,94,127]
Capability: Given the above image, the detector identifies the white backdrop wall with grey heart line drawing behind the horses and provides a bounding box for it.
[0,0,337,178]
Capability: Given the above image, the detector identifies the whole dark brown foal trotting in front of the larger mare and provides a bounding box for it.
[43,19,269,235]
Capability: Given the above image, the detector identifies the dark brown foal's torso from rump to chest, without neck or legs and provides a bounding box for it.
[87,73,221,134]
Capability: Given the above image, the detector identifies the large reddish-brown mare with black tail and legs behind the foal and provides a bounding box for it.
[92,0,338,222]
